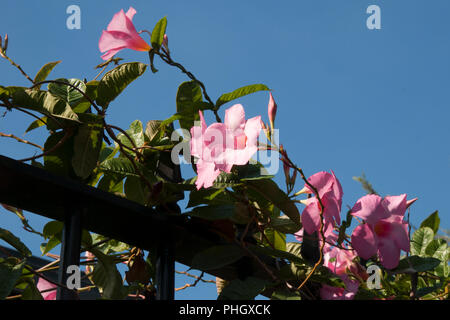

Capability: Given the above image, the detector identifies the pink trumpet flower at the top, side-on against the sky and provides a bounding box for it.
[98,7,151,60]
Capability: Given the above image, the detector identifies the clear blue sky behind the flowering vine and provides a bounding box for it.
[0,0,450,299]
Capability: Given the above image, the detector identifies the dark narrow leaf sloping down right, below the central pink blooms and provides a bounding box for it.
[246,179,301,228]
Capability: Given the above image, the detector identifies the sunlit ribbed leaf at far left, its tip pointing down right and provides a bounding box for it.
[12,89,80,123]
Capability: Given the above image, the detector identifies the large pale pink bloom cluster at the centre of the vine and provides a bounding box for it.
[191,104,261,189]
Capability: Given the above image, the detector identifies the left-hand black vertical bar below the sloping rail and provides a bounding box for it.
[56,206,81,300]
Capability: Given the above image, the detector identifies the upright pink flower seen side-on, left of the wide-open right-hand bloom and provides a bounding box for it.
[302,171,343,234]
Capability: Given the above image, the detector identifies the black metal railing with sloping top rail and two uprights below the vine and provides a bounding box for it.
[0,156,271,300]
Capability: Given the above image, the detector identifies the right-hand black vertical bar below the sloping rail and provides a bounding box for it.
[156,233,175,301]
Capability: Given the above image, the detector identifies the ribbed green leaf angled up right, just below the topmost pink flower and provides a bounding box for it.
[96,62,147,108]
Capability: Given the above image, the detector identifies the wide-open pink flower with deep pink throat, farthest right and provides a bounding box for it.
[352,194,417,269]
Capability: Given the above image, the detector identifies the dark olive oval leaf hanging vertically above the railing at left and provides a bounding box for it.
[72,114,103,179]
